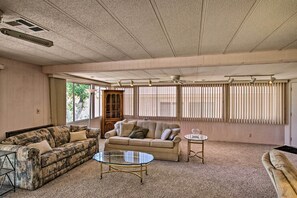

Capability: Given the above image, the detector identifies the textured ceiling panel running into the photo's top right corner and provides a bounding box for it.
[226,0,297,53]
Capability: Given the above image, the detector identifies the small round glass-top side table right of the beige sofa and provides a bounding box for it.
[185,134,208,164]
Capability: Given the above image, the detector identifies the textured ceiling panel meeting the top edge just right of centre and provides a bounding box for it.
[155,0,202,56]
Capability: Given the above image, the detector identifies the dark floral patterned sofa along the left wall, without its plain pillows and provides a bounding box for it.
[0,126,100,190]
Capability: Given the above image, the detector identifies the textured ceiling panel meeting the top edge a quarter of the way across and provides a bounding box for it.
[50,0,150,59]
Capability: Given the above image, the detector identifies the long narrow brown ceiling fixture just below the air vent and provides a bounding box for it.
[0,28,54,47]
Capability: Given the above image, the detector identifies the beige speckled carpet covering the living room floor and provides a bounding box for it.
[5,141,297,198]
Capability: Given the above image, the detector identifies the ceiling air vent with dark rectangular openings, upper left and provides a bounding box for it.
[5,18,47,33]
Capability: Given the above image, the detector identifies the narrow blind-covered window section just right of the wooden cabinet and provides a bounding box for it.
[117,87,134,116]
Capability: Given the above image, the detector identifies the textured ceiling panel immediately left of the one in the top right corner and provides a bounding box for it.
[200,0,256,54]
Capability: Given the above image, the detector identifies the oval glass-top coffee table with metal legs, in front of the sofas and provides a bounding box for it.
[93,151,154,184]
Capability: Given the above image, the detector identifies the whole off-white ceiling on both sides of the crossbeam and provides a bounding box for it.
[0,0,297,82]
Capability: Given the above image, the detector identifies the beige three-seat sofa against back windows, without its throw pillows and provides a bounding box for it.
[104,120,181,161]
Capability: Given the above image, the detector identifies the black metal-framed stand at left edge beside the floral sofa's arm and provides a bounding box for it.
[0,150,16,197]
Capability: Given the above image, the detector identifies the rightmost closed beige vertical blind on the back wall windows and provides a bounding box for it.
[229,82,286,124]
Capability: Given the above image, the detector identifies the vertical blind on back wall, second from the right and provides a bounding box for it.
[181,85,224,121]
